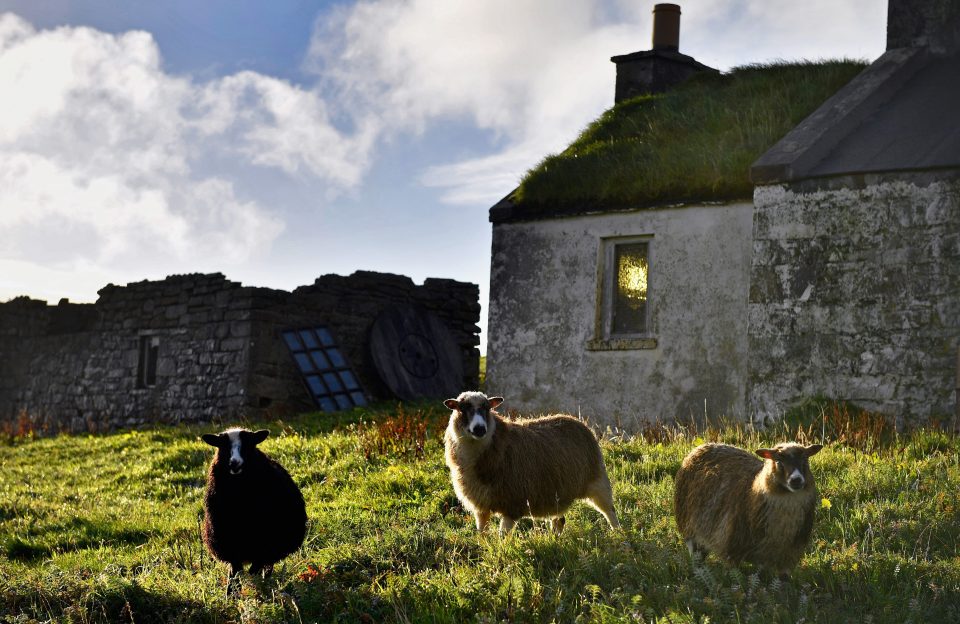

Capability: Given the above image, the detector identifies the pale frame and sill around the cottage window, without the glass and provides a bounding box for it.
[587,234,657,351]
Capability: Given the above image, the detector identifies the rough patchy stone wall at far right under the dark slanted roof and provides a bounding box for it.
[748,174,960,421]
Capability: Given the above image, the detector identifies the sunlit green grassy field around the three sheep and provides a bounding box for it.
[0,405,960,623]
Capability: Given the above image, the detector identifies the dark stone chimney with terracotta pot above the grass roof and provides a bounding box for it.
[610,0,716,102]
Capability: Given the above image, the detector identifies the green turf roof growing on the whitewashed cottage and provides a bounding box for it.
[513,60,866,207]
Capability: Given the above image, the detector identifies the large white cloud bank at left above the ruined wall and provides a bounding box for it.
[0,13,376,299]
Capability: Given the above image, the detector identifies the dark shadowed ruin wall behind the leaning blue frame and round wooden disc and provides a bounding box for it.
[250,271,480,409]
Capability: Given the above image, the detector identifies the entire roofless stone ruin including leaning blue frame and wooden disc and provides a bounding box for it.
[0,271,480,431]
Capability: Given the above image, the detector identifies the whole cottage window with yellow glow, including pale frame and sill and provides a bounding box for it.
[587,237,657,351]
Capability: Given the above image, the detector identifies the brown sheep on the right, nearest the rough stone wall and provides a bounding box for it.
[673,442,823,575]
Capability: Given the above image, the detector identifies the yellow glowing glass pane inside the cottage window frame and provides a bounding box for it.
[610,243,649,334]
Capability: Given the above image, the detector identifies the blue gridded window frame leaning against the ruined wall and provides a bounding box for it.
[283,327,367,412]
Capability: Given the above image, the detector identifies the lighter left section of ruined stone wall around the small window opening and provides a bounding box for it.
[0,274,252,431]
